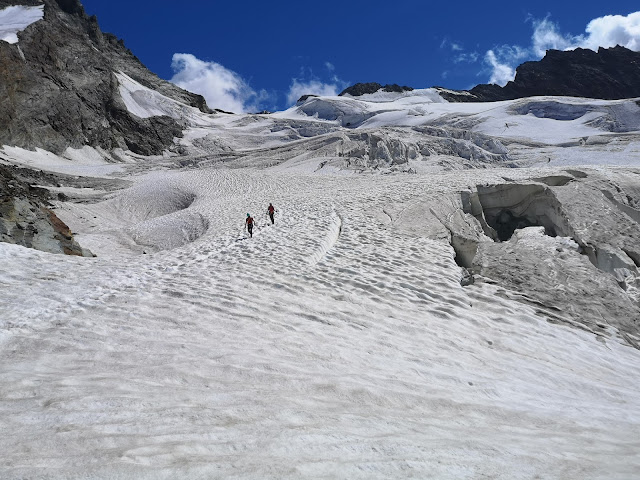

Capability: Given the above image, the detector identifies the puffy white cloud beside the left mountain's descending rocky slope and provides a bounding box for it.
[171,53,268,113]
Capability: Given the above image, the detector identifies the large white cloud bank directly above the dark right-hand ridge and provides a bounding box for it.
[484,12,640,85]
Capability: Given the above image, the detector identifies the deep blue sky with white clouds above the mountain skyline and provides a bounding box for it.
[83,0,640,111]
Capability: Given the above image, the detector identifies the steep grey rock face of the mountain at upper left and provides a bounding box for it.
[0,0,209,155]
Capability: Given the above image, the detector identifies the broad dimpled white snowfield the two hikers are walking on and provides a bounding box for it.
[0,165,640,480]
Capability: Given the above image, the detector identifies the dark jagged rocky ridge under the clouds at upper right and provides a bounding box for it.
[438,45,640,102]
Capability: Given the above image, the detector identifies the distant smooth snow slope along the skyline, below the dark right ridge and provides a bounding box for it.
[277,89,640,144]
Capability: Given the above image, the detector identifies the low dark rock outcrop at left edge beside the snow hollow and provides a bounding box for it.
[0,165,93,257]
